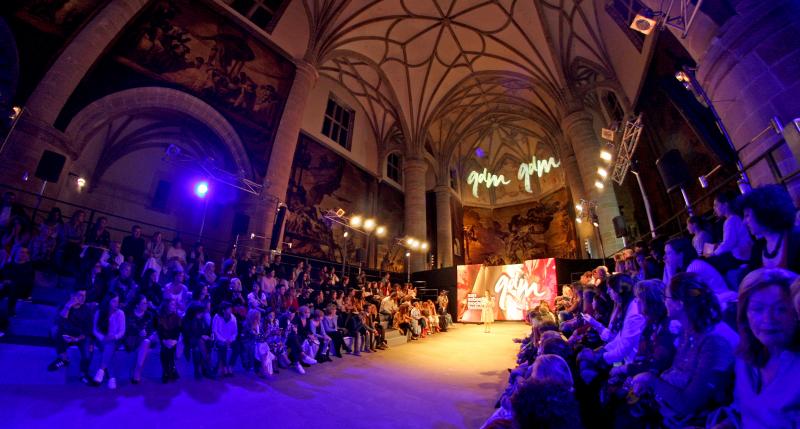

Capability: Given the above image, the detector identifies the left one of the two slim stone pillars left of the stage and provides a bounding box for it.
[403,157,428,272]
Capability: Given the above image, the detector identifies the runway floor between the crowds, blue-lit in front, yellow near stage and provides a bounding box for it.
[0,323,527,429]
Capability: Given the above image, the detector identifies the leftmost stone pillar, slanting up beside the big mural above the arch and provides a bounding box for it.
[25,0,149,124]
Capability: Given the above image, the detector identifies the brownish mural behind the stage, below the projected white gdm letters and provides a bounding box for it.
[463,188,577,265]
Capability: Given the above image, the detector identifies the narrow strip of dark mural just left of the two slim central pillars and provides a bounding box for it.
[377,182,405,273]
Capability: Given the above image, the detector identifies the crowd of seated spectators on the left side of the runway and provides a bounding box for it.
[0,193,452,389]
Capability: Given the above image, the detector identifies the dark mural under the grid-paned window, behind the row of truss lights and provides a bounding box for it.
[285,135,375,262]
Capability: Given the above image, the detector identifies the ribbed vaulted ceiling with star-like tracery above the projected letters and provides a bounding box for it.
[272,0,640,187]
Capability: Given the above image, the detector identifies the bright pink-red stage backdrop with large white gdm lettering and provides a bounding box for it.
[458,258,558,322]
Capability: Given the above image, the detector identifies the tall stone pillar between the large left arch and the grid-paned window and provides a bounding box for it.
[260,59,319,243]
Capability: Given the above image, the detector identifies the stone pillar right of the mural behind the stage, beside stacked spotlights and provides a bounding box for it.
[561,110,622,256]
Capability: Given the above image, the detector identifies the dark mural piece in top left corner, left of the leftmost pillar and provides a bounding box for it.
[12,0,109,39]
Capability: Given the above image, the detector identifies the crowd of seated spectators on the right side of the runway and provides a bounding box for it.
[484,185,800,429]
